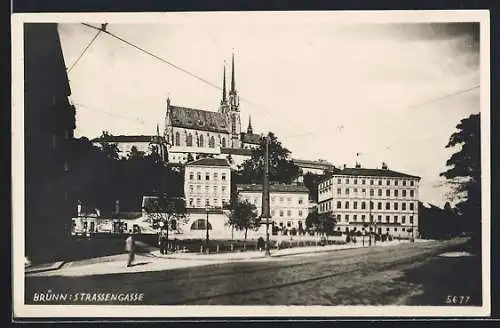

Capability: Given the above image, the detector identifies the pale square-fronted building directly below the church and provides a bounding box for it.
[184,158,231,209]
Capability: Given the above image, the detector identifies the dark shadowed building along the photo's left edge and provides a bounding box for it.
[24,23,76,258]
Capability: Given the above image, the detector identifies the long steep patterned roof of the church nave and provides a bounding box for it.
[169,106,229,133]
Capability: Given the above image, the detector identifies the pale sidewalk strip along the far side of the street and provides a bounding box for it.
[26,241,418,277]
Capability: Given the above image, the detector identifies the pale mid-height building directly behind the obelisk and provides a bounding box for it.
[237,184,310,233]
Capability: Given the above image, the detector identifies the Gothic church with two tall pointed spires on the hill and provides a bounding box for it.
[164,55,261,163]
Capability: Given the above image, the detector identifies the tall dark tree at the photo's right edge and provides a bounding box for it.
[440,114,481,236]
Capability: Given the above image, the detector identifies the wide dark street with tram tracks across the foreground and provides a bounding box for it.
[25,240,481,306]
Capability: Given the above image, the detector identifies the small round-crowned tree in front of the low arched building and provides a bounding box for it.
[144,195,186,251]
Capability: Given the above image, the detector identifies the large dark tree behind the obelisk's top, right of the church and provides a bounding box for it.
[240,132,300,184]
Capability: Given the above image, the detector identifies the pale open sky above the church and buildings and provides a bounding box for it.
[59,14,480,206]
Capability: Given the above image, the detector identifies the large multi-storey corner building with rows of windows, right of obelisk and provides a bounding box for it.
[318,164,420,237]
